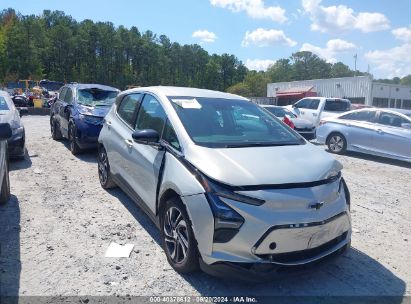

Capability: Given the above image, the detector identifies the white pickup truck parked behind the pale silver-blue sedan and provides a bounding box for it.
[287,97,351,126]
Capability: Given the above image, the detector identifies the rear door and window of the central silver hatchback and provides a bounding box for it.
[105,93,142,178]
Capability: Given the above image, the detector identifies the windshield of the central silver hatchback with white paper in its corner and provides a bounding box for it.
[169,97,305,148]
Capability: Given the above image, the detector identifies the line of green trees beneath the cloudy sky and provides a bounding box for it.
[0,8,411,97]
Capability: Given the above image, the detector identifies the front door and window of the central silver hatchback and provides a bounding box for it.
[127,94,166,213]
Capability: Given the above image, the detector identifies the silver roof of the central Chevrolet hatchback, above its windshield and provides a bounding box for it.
[119,86,248,101]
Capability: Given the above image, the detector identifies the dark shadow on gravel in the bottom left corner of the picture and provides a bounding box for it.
[0,195,21,303]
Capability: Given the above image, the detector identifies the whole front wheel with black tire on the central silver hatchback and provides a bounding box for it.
[160,198,199,273]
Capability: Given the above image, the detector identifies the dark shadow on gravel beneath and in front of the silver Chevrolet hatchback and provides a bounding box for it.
[108,188,406,296]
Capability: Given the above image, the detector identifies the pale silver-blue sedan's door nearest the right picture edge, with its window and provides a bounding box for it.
[374,111,411,159]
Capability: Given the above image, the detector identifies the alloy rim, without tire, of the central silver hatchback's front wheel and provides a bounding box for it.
[164,207,190,264]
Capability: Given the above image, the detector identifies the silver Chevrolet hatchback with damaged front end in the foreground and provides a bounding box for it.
[98,87,351,275]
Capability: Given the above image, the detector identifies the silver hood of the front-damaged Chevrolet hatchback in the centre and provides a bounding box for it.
[185,143,342,186]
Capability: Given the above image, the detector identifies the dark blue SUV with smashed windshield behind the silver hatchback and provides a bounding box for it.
[50,83,119,154]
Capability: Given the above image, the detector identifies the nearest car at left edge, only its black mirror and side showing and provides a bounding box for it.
[0,121,12,205]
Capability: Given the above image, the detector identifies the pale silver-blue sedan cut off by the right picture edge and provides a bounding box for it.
[317,108,411,161]
